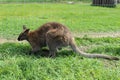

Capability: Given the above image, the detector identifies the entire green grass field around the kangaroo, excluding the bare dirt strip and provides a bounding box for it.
[0,3,120,80]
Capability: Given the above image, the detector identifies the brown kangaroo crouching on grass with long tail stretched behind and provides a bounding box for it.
[18,22,119,60]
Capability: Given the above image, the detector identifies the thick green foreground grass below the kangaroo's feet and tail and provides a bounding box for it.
[0,43,120,80]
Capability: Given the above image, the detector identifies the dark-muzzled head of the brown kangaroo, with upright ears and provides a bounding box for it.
[18,25,30,41]
